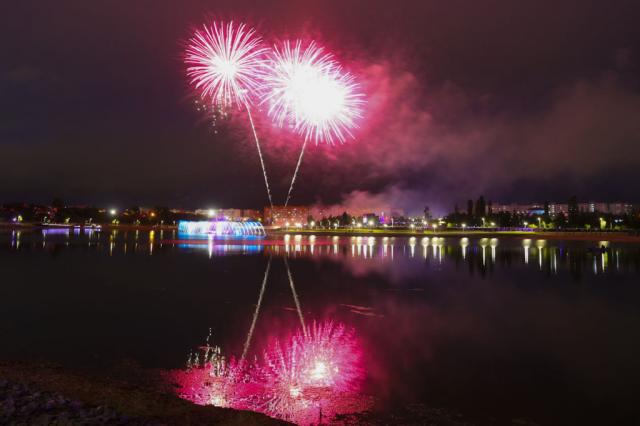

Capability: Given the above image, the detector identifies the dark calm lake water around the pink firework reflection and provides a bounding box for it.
[0,230,640,424]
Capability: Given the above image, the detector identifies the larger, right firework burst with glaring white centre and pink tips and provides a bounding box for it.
[262,40,364,144]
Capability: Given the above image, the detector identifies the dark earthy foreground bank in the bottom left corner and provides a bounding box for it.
[0,363,285,425]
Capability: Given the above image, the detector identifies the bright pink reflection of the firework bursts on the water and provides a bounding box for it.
[169,322,364,424]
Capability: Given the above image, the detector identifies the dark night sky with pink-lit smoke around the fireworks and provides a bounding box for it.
[0,0,640,211]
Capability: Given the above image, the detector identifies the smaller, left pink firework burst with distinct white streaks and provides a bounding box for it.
[185,22,267,108]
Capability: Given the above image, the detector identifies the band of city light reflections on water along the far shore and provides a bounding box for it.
[0,228,638,278]
